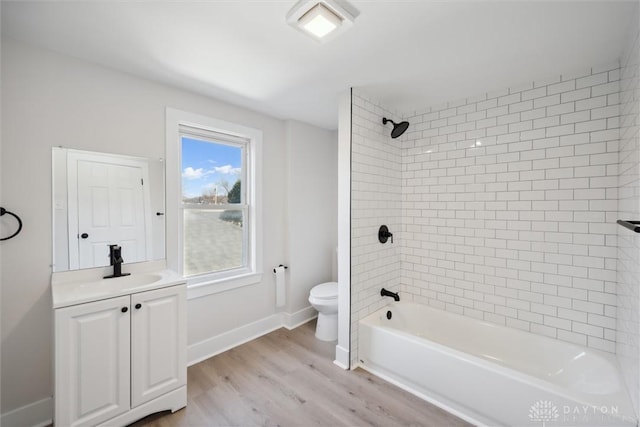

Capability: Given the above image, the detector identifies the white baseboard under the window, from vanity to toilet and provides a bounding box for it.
[187,306,317,366]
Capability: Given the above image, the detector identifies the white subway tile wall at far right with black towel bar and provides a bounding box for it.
[615,3,640,413]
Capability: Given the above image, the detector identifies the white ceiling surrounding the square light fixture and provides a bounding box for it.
[1,0,637,129]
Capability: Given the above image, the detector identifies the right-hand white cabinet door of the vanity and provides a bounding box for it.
[131,285,187,407]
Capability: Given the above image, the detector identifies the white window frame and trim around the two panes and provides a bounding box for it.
[166,108,263,299]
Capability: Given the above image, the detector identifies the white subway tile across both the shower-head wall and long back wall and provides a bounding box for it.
[352,64,620,363]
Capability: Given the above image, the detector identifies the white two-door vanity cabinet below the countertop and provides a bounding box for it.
[54,284,187,427]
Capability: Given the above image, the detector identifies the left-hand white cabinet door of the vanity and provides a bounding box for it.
[55,296,130,426]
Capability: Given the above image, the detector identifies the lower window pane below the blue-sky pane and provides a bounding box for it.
[183,209,245,276]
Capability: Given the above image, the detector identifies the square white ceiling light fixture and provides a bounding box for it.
[287,0,355,42]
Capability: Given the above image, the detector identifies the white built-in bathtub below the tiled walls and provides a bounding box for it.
[358,303,637,427]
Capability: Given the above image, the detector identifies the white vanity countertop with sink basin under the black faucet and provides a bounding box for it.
[51,262,185,309]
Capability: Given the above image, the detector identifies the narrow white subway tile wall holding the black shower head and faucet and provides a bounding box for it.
[351,91,402,366]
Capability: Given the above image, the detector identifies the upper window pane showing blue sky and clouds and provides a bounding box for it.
[182,136,243,205]
